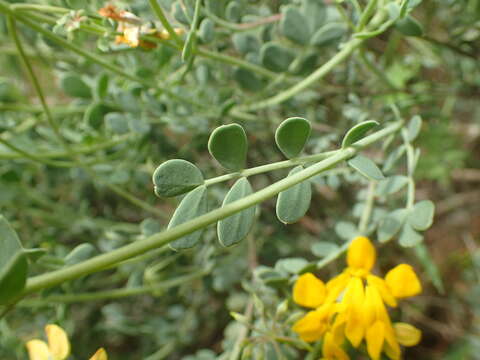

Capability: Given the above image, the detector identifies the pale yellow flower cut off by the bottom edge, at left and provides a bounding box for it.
[25,324,108,360]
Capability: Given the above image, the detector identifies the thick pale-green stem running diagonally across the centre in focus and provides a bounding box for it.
[17,122,403,297]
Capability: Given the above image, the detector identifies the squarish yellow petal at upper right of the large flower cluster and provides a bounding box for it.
[385,264,422,299]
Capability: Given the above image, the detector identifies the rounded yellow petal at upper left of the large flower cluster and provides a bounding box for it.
[293,273,326,308]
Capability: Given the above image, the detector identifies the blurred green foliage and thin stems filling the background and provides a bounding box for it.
[0,0,480,360]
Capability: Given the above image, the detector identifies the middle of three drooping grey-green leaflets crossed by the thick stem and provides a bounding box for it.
[217,177,255,246]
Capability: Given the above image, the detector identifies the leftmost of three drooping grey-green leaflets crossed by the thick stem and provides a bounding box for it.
[167,185,208,250]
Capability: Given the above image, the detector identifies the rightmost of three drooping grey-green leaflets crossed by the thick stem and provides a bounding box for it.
[276,165,312,224]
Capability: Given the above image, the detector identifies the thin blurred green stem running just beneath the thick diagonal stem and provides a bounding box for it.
[22,271,207,307]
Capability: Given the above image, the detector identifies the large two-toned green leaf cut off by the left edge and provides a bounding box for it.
[0,215,28,304]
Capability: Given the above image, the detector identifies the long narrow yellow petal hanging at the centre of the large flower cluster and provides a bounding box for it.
[343,278,365,347]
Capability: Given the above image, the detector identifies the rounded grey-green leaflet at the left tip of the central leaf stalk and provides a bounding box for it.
[152,159,203,197]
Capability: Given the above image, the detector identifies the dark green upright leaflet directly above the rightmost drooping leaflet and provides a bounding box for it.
[275,117,312,159]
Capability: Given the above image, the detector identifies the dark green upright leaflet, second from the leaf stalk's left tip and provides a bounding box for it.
[208,124,248,171]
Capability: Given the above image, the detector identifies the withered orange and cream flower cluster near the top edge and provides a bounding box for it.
[98,5,184,49]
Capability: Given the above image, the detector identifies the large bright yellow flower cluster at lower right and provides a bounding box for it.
[293,236,422,360]
